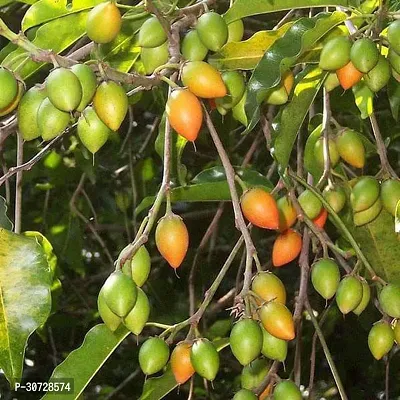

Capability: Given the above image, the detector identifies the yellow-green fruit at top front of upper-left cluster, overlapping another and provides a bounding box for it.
[46,68,82,111]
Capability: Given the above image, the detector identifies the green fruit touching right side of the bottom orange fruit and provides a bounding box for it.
[190,339,219,381]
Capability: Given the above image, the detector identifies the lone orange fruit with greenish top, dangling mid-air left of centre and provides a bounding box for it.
[156,213,189,269]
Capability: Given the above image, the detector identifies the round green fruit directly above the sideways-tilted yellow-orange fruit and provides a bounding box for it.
[196,12,228,51]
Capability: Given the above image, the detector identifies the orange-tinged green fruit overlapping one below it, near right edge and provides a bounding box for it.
[350,176,380,212]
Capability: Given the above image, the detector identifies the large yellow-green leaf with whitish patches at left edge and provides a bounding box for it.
[0,228,52,388]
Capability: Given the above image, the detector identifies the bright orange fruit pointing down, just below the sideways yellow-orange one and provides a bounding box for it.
[165,89,203,142]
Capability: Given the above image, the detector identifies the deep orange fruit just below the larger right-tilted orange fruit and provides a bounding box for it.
[272,229,303,267]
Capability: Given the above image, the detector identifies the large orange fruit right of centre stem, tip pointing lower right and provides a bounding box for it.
[241,187,279,229]
